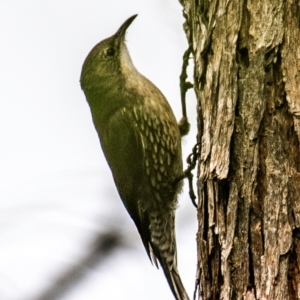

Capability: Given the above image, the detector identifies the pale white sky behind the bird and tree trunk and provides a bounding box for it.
[0,0,197,300]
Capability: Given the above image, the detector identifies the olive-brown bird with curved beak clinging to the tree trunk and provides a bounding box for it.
[80,15,189,300]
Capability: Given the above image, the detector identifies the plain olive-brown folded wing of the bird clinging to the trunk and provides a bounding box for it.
[97,108,151,259]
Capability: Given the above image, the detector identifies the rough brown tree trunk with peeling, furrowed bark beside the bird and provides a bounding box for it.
[181,0,300,300]
